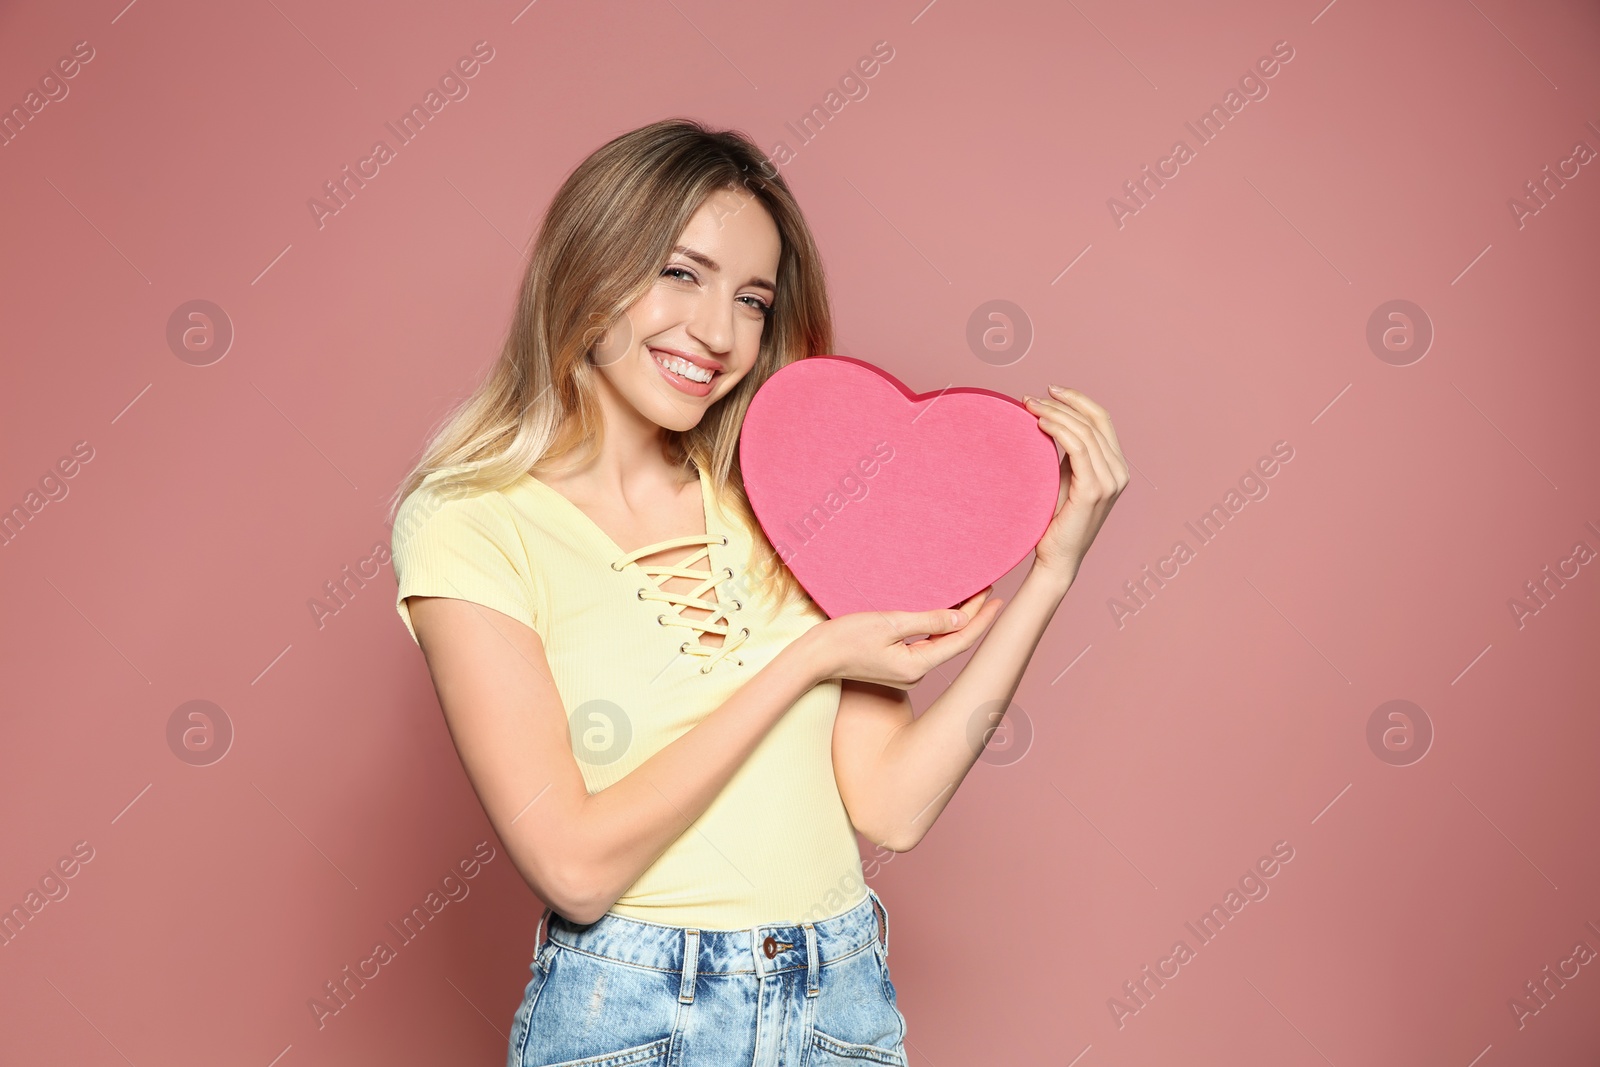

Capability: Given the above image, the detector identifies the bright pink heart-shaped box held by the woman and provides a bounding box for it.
[739,355,1061,619]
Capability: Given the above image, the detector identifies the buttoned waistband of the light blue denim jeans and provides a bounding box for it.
[549,886,888,982]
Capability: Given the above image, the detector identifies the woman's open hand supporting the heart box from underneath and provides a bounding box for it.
[802,585,1003,689]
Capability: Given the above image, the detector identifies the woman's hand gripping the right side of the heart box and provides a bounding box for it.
[1024,386,1128,584]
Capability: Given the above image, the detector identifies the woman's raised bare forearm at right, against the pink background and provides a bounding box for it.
[874,565,1077,851]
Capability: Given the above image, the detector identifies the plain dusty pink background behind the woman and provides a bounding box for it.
[0,0,1600,1067]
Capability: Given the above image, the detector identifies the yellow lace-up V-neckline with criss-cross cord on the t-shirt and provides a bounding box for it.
[528,466,750,673]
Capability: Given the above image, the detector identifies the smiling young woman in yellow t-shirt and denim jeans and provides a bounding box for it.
[394,120,1128,1067]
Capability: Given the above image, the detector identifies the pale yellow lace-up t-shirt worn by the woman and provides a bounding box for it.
[394,470,866,929]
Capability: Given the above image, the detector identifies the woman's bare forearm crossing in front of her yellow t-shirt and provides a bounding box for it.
[553,638,822,921]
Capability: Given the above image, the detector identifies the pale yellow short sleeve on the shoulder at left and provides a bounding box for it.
[390,482,538,645]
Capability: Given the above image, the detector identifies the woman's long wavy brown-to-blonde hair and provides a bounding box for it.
[389,118,834,609]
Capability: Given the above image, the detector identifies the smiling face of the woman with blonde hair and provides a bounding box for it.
[589,189,782,430]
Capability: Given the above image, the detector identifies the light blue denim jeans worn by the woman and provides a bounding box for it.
[506,888,906,1067]
